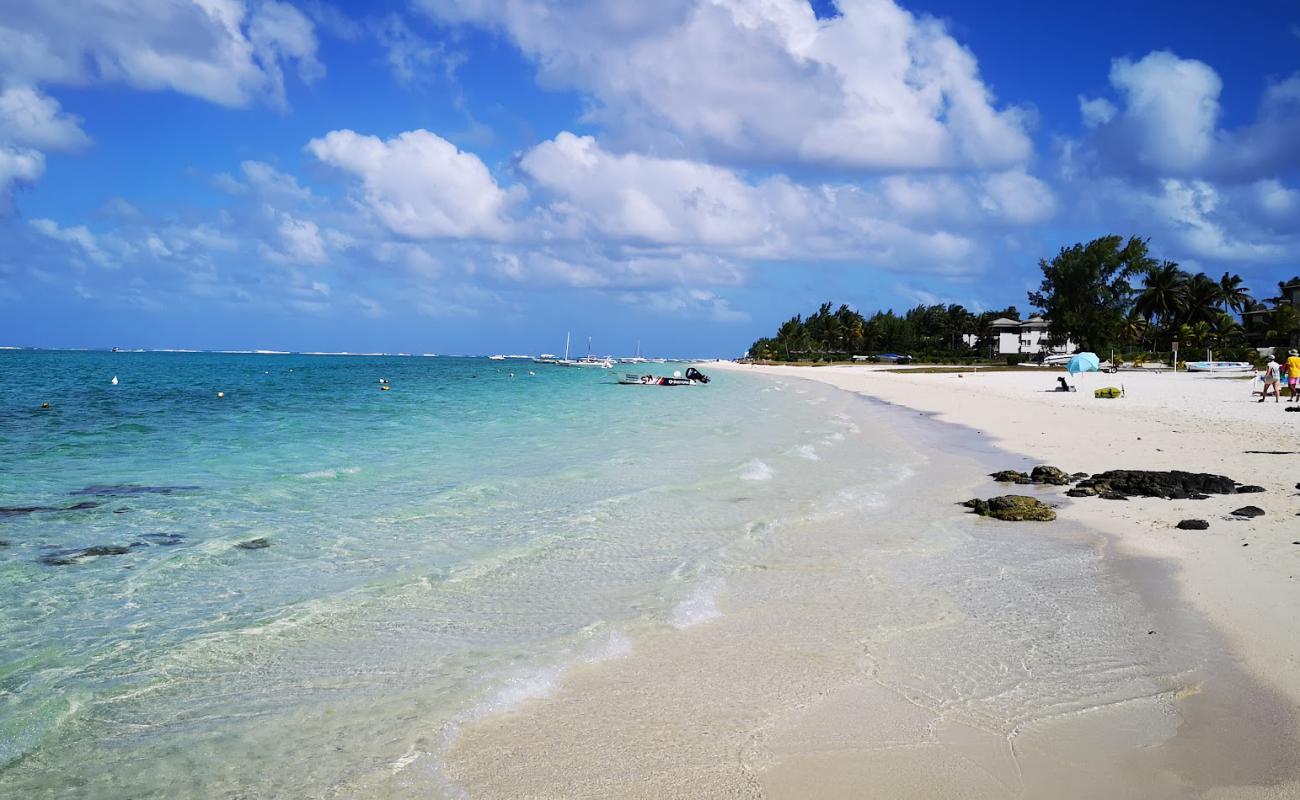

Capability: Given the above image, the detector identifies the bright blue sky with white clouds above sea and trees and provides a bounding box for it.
[0,0,1300,356]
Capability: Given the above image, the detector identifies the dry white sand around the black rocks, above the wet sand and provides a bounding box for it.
[714,363,1300,797]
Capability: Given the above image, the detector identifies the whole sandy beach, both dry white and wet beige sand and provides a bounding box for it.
[447,364,1300,800]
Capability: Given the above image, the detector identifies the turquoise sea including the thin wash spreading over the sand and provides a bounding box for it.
[0,351,1237,799]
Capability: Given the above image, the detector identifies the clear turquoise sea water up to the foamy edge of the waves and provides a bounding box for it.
[0,351,904,797]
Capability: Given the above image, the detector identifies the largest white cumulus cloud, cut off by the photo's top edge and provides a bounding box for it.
[419,0,1032,169]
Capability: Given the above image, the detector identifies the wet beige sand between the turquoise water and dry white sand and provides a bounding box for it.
[445,372,1300,799]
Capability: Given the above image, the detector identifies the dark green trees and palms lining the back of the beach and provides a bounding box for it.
[749,235,1300,360]
